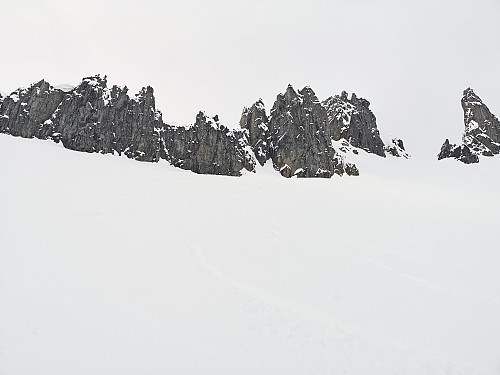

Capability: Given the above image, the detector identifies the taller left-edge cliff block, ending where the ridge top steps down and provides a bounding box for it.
[0,76,163,161]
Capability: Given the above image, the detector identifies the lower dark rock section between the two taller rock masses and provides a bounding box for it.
[162,112,255,176]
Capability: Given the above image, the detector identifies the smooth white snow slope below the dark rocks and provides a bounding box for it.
[0,134,500,375]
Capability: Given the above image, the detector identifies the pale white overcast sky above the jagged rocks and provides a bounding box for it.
[0,0,500,158]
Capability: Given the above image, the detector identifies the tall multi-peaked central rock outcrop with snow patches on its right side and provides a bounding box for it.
[240,85,402,177]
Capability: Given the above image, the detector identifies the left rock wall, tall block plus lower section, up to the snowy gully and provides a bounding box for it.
[0,75,255,176]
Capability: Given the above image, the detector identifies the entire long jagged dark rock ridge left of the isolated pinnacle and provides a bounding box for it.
[0,75,406,177]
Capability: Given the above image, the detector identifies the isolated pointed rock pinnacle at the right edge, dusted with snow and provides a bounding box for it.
[438,88,500,164]
